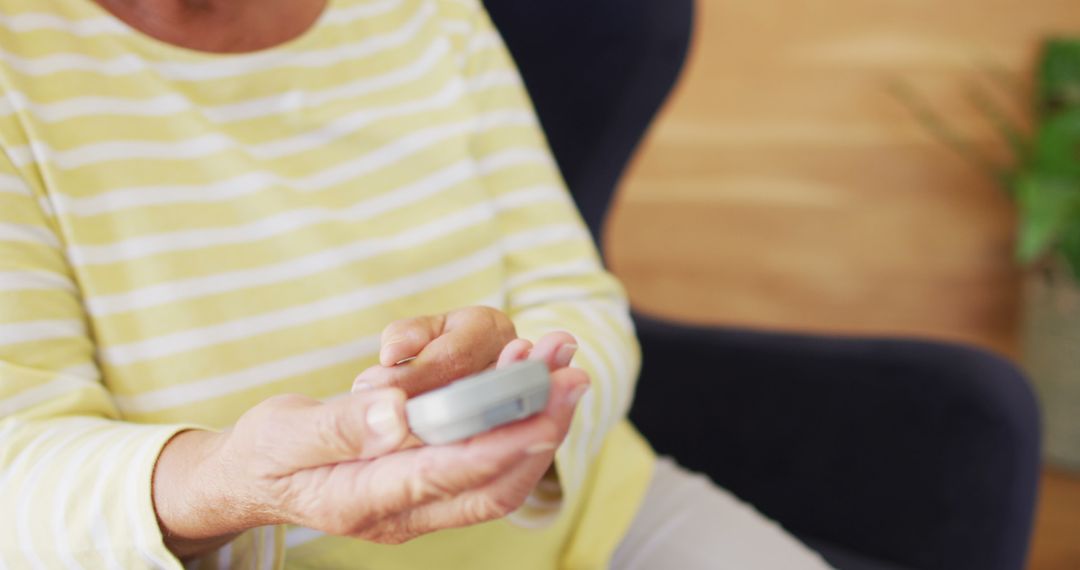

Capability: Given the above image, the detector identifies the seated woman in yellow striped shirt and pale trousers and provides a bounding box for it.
[0,0,823,569]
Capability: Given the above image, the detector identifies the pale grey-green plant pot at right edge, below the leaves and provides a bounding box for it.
[1024,270,1080,471]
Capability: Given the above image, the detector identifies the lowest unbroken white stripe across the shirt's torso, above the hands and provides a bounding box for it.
[102,248,499,366]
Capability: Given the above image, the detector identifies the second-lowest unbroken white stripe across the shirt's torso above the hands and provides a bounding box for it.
[86,180,557,317]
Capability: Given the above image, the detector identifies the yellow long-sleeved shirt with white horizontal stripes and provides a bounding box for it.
[0,0,651,569]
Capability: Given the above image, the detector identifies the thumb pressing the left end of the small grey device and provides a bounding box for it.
[296,388,408,466]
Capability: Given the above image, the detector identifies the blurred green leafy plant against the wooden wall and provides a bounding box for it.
[893,39,1080,281]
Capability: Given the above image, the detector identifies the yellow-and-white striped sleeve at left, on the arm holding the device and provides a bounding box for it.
[0,148,278,569]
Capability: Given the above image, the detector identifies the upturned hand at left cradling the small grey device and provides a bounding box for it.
[153,349,589,558]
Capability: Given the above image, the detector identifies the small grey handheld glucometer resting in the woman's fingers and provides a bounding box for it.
[405,361,551,445]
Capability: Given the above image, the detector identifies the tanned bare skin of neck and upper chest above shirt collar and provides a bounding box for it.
[95,0,327,53]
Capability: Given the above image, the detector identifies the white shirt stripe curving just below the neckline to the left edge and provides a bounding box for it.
[0,2,436,81]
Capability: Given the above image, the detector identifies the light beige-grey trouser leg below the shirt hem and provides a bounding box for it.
[611,458,829,570]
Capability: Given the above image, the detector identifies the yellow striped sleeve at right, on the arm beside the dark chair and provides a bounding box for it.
[444,2,639,492]
